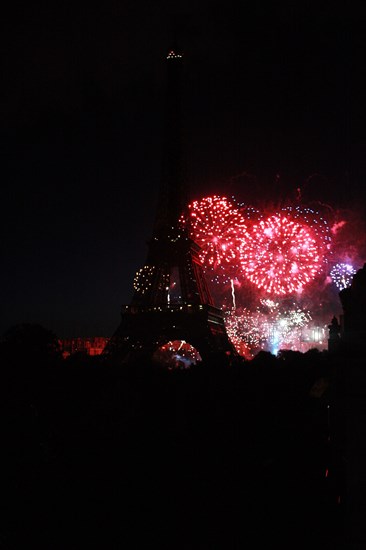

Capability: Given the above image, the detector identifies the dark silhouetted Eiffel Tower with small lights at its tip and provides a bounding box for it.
[105,50,236,363]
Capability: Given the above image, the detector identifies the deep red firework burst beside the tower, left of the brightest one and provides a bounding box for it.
[181,195,249,278]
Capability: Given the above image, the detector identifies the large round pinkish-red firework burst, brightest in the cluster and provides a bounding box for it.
[241,214,323,295]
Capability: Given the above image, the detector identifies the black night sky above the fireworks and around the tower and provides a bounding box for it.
[0,0,366,337]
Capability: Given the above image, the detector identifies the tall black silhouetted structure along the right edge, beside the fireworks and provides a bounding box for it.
[329,264,366,550]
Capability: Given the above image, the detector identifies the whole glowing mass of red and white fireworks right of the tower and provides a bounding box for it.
[174,195,359,358]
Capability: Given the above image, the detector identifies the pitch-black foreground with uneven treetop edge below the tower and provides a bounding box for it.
[0,354,347,550]
